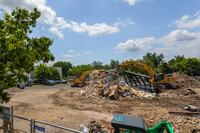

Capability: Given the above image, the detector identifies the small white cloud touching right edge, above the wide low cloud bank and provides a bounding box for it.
[174,11,200,29]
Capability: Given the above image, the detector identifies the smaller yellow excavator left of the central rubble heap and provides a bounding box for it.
[69,69,93,87]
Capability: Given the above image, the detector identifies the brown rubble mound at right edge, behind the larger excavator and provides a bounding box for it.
[173,72,200,88]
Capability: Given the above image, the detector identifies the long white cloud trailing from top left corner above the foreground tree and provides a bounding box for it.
[0,0,128,38]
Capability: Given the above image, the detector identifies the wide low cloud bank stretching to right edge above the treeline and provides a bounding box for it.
[115,30,200,60]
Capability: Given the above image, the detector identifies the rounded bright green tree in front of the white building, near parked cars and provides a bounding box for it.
[34,64,52,80]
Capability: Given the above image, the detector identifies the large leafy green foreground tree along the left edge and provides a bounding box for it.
[0,8,54,103]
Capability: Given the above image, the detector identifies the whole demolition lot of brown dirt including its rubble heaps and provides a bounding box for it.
[4,67,200,133]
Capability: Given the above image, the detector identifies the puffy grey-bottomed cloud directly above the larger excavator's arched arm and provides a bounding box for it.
[114,37,156,53]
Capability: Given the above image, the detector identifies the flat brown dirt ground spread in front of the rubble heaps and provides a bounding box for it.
[5,84,200,133]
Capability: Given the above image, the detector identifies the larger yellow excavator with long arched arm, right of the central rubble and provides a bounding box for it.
[116,61,177,92]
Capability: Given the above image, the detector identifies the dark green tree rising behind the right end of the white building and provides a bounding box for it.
[53,61,72,77]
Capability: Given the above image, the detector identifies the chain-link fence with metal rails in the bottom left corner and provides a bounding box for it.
[0,113,82,133]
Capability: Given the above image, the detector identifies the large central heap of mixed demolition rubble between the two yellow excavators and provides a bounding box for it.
[81,70,155,99]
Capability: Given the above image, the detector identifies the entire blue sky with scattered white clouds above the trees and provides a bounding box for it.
[0,0,200,65]
